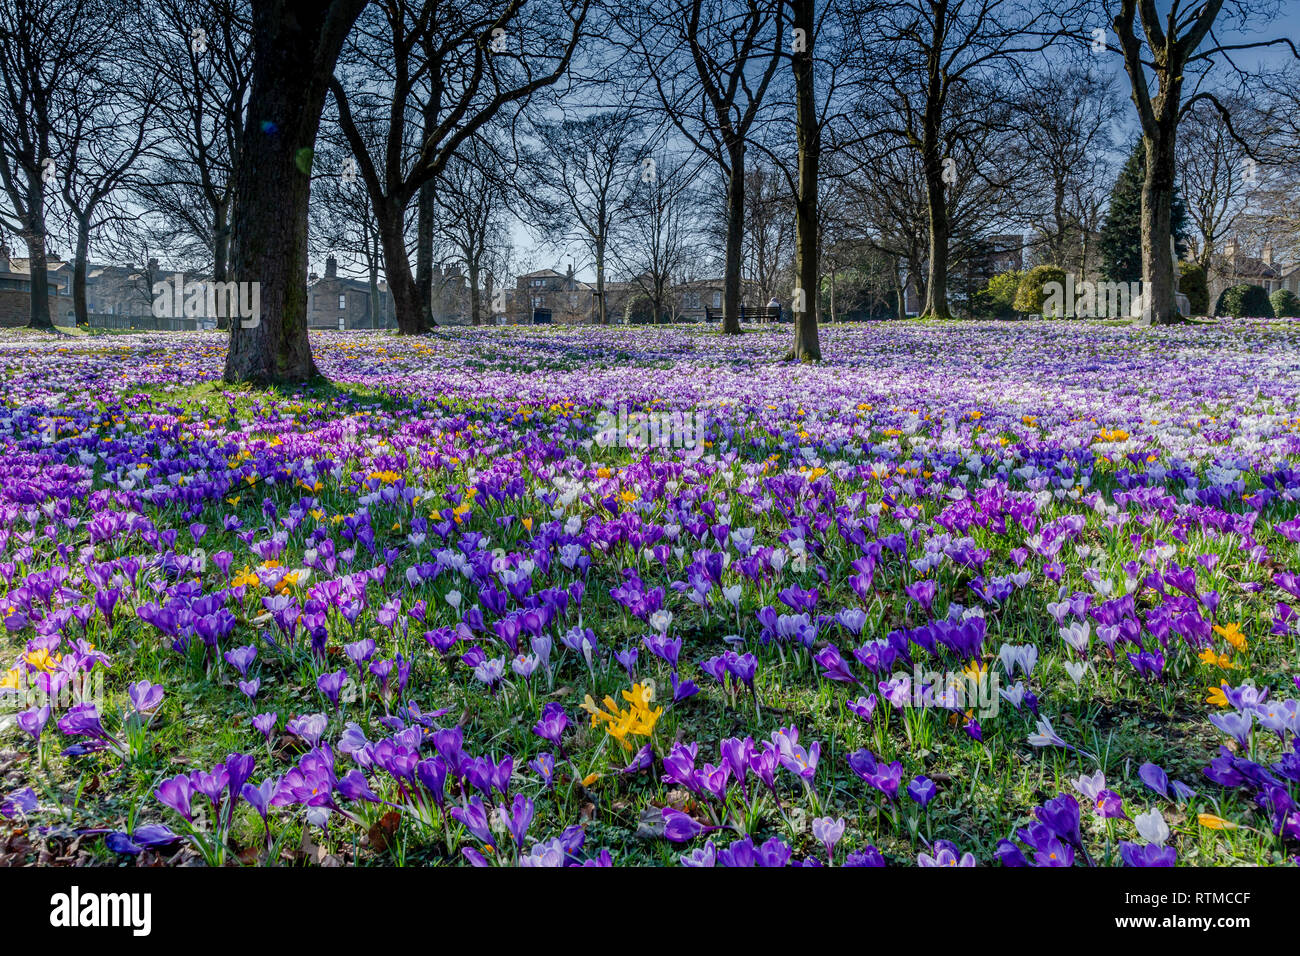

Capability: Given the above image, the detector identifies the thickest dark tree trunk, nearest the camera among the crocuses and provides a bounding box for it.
[225,0,365,386]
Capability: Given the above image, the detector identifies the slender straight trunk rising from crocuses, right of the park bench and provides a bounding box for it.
[787,0,822,362]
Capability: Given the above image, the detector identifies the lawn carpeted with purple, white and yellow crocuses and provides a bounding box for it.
[0,321,1300,866]
